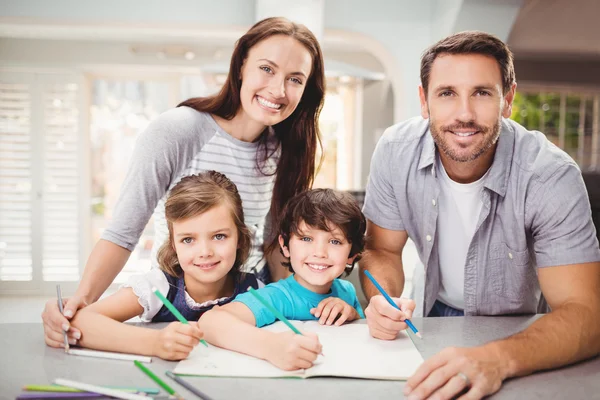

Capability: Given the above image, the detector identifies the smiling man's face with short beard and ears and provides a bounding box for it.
[419,54,515,163]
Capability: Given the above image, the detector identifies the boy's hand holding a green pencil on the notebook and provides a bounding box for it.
[267,332,322,371]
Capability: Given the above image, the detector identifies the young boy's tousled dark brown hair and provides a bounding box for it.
[279,189,367,275]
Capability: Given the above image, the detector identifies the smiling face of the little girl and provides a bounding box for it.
[173,205,238,286]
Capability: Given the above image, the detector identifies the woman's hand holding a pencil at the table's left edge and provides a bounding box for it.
[42,295,88,347]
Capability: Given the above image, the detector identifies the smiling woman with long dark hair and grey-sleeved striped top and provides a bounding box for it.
[42,18,325,347]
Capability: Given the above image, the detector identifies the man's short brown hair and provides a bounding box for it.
[421,31,515,94]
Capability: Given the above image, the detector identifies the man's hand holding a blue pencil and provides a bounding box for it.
[365,295,415,340]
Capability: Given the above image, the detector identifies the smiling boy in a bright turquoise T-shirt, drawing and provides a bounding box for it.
[198,189,366,370]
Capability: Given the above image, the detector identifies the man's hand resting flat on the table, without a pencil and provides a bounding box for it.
[404,346,508,400]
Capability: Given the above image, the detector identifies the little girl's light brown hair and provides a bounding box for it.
[157,171,252,278]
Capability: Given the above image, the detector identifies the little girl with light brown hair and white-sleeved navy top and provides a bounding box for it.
[73,171,258,360]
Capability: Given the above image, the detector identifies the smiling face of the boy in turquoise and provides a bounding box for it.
[279,221,354,294]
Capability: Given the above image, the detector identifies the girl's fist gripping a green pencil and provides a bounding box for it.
[152,322,204,361]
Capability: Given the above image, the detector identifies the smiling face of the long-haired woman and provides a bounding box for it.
[240,35,312,126]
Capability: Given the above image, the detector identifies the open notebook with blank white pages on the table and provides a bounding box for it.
[173,321,423,380]
